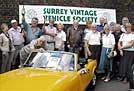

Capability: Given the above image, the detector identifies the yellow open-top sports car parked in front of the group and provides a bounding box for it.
[0,51,97,91]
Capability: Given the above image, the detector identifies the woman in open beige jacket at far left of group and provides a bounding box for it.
[0,23,15,73]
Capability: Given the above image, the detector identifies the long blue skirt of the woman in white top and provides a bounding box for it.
[98,47,113,71]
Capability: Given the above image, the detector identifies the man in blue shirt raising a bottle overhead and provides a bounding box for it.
[22,16,42,44]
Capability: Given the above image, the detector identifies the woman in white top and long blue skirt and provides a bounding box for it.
[99,25,115,82]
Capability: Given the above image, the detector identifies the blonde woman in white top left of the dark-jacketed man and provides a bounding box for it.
[55,23,66,51]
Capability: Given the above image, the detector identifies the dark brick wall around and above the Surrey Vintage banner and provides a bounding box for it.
[0,0,134,24]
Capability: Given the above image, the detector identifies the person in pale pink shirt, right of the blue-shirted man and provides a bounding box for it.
[42,19,57,50]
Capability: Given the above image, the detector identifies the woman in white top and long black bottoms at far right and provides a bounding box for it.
[118,23,134,83]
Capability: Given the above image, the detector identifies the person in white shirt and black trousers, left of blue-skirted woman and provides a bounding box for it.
[84,24,101,62]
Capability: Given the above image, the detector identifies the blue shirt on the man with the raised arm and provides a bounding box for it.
[22,20,42,43]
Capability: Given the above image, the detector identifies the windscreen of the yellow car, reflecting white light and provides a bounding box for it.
[26,52,75,71]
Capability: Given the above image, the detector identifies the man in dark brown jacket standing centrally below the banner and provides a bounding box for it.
[67,20,84,54]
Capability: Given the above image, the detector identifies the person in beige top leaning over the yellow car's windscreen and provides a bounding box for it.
[20,36,46,64]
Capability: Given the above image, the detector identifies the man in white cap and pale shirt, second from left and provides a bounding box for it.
[8,20,24,68]
